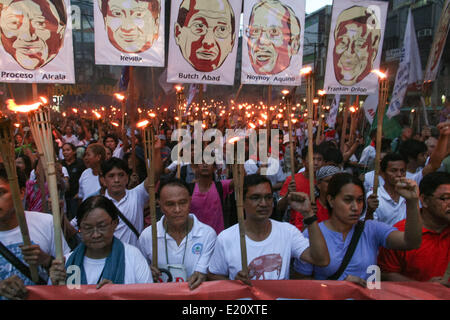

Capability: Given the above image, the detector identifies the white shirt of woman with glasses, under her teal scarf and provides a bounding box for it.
[62,243,153,284]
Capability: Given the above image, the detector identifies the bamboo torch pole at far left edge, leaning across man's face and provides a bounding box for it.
[0,118,39,284]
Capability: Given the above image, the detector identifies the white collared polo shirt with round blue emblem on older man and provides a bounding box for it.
[139,213,217,277]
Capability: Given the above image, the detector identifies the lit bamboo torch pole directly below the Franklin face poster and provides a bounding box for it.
[373,77,389,194]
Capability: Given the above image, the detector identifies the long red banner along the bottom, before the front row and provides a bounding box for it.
[27,280,450,300]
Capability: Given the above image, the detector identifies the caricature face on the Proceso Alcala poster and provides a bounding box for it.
[0,0,65,70]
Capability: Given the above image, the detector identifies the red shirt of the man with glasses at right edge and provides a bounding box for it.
[378,220,450,281]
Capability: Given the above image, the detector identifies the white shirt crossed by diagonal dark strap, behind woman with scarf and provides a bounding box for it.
[105,182,149,246]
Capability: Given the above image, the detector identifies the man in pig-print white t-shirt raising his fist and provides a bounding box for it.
[208,174,330,284]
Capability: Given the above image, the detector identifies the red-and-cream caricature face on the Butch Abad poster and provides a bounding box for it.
[175,0,234,72]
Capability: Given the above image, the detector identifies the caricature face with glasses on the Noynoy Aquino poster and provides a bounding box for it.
[246,0,301,74]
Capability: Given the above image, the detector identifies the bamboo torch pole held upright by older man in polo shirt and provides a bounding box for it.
[144,125,158,268]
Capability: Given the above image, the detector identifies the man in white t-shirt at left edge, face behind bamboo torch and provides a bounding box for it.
[0,164,69,299]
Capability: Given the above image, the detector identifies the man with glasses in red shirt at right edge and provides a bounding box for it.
[378,172,450,287]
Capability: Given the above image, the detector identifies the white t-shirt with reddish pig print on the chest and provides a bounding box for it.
[209,219,309,280]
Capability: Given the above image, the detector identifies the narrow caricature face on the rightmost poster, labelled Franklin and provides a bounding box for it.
[333,7,381,86]
